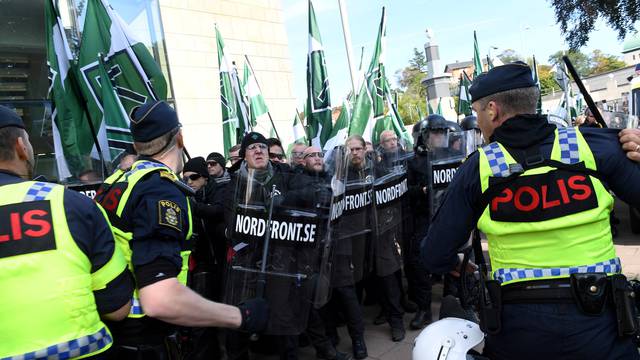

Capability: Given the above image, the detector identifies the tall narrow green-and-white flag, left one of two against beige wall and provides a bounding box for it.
[216,26,243,157]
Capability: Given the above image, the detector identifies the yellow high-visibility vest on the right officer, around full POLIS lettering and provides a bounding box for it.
[478,128,621,283]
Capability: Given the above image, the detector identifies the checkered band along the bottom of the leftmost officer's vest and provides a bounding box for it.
[1,327,113,360]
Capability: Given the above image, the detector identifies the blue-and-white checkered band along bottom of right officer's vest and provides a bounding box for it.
[493,258,622,283]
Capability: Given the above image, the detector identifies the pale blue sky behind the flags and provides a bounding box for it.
[282,0,622,108]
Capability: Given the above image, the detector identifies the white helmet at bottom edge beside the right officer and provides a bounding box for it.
[412,317,484,360]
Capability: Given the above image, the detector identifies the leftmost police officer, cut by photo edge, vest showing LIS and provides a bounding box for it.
[0,106,133,359]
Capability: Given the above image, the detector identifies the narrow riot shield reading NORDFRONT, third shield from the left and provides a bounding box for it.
[372,148,412,276]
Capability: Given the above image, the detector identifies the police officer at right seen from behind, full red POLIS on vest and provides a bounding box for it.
[422,62,640,360]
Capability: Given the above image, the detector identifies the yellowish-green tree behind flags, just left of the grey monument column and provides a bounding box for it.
[396,48,427,124]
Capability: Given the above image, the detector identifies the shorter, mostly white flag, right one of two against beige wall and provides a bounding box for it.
[242,55,277,137]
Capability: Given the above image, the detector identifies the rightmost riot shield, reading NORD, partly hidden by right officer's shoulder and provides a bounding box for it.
[428,130,480,217]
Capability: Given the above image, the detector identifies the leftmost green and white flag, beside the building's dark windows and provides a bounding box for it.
[45,0,94,180]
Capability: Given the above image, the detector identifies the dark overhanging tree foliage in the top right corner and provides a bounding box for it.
[551,0,640,50]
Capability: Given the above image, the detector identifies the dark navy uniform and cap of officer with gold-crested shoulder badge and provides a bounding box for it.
[96,102,190,359]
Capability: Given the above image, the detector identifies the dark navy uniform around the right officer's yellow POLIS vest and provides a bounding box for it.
[422,64,640,359]
